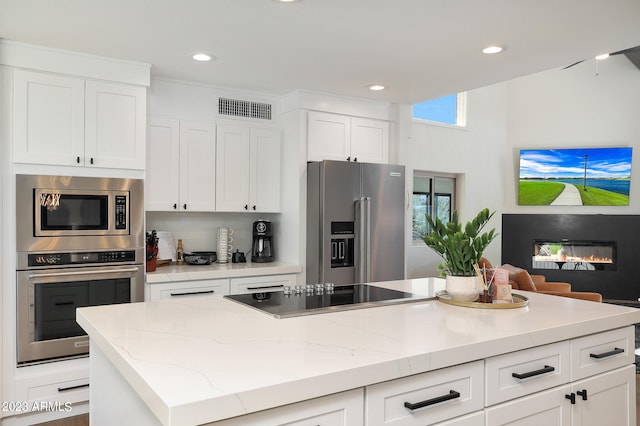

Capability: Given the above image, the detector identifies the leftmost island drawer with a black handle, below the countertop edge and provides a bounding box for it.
[365,361,484,426]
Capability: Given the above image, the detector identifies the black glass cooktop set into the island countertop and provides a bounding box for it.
[224,284,433,318]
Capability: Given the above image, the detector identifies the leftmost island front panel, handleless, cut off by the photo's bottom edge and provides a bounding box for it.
[214,388,364,426]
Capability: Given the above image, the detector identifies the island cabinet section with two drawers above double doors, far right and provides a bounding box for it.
[486,327,636,426]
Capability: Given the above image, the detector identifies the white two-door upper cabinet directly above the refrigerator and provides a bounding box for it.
[307,111,389,163]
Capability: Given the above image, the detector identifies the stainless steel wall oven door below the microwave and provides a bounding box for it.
[17,265,144,365]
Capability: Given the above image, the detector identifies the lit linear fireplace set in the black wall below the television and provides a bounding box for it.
[532,240,616,271]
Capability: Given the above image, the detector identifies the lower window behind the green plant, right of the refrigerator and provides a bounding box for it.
[412,172,456,240]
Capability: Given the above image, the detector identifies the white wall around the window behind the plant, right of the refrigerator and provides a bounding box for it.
[402,84,511,278]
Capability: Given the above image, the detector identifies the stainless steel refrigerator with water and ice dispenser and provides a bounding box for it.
[306,161,405,284]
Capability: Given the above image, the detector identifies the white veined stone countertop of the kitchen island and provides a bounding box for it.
[77,278,640,424]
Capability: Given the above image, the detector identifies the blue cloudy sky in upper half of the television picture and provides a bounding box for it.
[520,148,632,179]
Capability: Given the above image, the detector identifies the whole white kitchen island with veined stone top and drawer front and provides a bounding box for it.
[77,279,640,425]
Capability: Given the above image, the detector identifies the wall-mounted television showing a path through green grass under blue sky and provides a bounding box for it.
[518,147,633,206]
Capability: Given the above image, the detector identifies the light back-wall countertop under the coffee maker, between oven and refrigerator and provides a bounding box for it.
[146,262,302,284]
